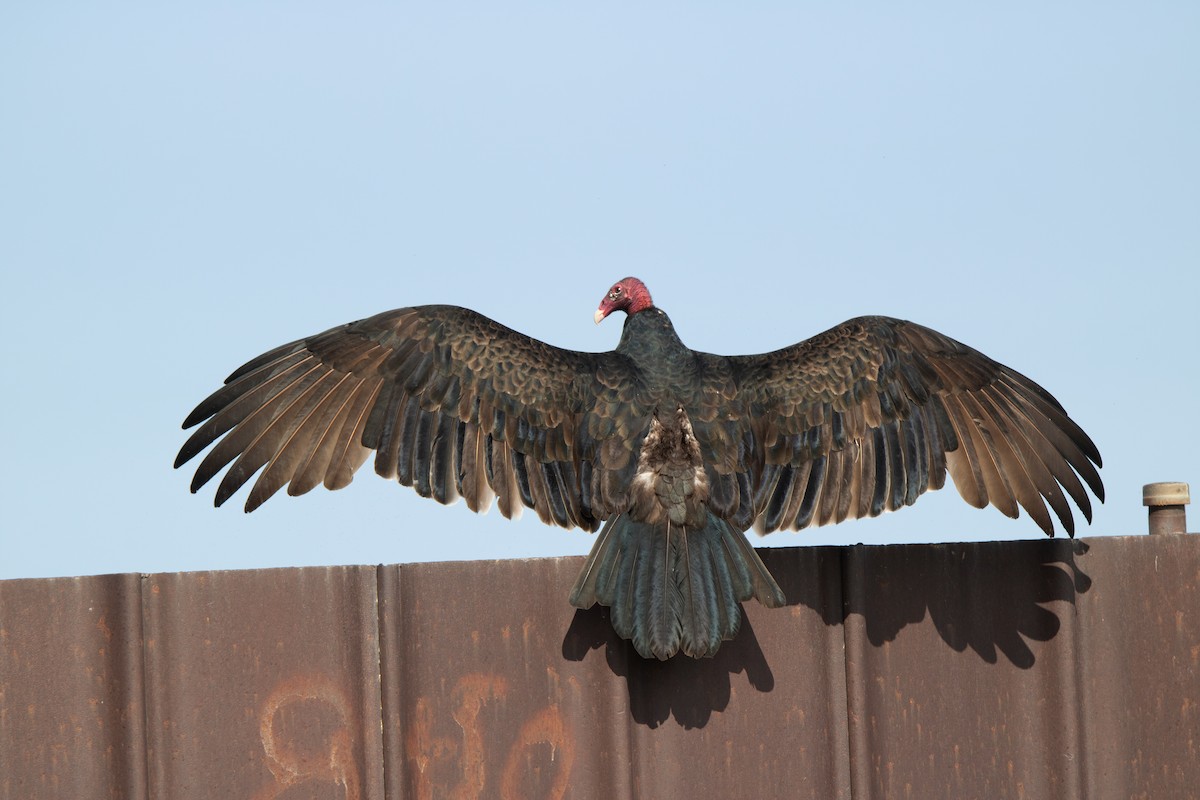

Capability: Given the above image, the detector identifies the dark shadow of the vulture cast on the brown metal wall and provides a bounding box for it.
[563,539,1092,728]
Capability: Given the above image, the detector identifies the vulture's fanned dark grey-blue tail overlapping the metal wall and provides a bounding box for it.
[571,513,785,660]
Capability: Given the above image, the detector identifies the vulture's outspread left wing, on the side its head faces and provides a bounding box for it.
[175,306,649,530]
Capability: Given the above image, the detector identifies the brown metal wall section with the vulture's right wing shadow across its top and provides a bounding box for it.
[846,540,1096,799]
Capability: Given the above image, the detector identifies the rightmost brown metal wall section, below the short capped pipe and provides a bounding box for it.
[1073,536,1200,800]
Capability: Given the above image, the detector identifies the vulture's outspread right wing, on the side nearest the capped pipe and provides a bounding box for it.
[713,317,1104,535]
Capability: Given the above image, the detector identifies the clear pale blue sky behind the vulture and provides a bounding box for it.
[0,2,1200,578]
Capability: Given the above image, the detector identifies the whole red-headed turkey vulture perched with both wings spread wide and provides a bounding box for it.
[175,278,1104,658]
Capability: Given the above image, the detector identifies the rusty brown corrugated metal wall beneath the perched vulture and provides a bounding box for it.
[0,536,1200,800]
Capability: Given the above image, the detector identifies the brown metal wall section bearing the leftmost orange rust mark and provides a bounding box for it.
[143,567,383,800]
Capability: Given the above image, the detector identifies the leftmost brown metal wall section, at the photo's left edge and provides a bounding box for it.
[0,575,146,800]
